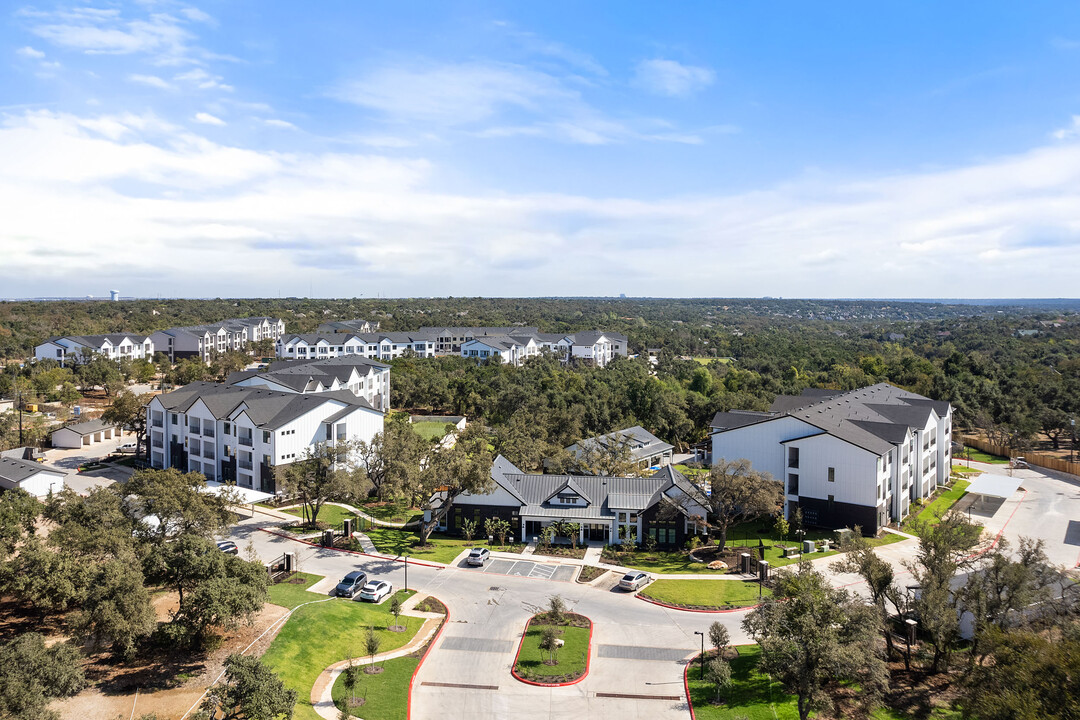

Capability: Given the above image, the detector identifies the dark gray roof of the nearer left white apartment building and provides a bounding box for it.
[158,382,378,430]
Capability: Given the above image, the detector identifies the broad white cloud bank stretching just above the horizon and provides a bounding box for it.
[0,111,1080,297]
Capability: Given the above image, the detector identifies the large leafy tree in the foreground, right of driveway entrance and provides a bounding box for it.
[743,563,889,720]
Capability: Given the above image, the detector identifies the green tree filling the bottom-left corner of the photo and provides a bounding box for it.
[0,633,86,720]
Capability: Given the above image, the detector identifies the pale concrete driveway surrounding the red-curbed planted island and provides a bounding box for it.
[231,514,748,720]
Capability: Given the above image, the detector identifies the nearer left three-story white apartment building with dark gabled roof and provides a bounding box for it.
[146,382,383,492]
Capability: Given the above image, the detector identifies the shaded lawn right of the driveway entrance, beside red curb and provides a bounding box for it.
[687,643,799,720]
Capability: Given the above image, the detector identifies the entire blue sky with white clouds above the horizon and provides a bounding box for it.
[0,0,1080,297]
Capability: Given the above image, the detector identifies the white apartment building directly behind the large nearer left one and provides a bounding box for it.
[226,354,390,412]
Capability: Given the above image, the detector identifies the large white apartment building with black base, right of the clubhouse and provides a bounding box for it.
[711,383,953,534]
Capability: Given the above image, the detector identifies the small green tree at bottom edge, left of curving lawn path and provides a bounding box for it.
[203,653,296,720]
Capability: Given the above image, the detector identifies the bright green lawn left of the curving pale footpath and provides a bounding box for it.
[262,590,423,720]
